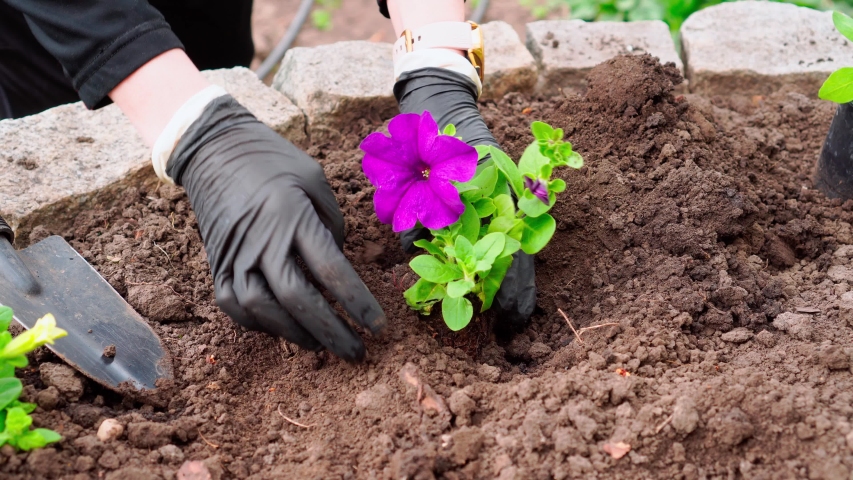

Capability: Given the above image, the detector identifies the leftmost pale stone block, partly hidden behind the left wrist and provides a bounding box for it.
[0,68,305,244]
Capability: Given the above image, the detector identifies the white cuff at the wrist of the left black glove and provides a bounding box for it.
[151,85,228,185]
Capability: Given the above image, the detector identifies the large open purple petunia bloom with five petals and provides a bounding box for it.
[361,112,477,232]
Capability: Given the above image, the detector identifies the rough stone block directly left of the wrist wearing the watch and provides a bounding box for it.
[273,41,398,142]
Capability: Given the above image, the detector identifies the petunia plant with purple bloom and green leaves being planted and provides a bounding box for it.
[361,112,583,331]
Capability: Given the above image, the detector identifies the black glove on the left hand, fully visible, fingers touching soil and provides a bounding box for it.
[166,96,386,360]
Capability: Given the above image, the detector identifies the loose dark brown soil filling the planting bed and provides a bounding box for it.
[5,57,853,480]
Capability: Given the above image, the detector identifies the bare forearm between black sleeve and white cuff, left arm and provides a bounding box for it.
[109,49,210,146]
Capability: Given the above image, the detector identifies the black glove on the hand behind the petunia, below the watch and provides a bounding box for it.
[394,68,536,326]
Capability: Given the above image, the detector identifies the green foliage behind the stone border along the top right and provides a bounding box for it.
[519,0,853,32]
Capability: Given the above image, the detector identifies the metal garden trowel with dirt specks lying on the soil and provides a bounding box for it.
[0,217,172,393]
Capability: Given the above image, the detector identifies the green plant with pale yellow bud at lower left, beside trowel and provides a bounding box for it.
[0,306,67,451]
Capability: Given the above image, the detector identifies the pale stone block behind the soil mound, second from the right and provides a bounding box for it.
[527,20,682,94]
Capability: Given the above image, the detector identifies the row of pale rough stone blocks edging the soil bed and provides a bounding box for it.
[0,2,853,234]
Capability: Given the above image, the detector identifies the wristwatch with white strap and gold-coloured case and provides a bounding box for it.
[394,21,485,82]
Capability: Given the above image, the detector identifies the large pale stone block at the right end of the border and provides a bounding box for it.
[681,2,853,97]
